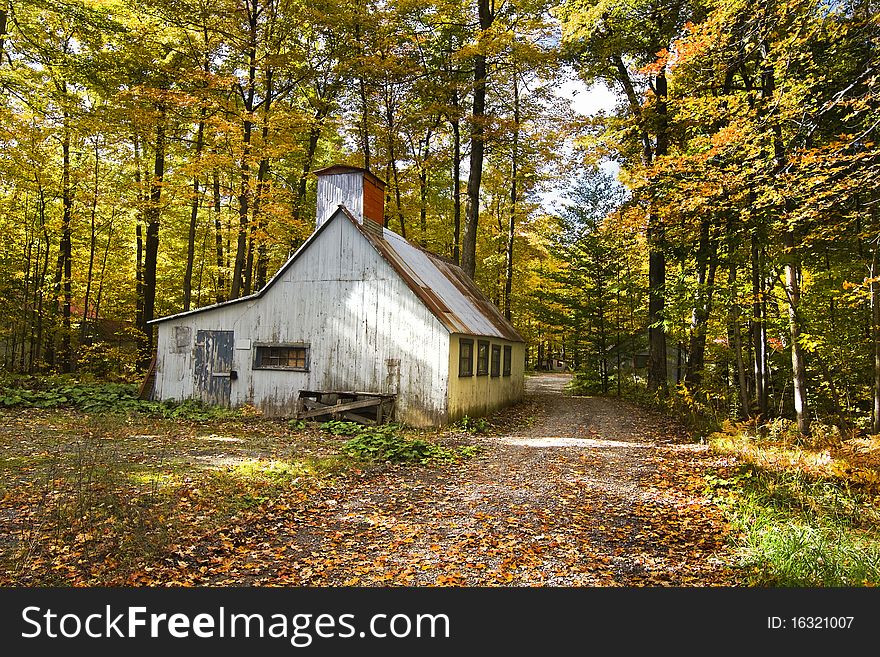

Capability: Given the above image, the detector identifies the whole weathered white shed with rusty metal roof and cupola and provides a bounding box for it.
[152,165,525,426]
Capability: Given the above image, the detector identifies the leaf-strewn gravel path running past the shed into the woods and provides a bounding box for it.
[198,374,733,586]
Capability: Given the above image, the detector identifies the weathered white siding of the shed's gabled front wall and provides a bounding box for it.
[155,217,449,426]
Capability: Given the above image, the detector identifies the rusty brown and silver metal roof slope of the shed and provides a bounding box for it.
[340,206,525,342]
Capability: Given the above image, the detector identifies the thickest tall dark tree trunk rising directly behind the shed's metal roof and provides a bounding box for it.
[461,0,495,278]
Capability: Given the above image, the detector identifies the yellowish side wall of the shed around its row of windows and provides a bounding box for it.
[447,335,526,422]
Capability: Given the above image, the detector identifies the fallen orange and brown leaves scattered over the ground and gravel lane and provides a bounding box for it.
[0,376,734,586]
